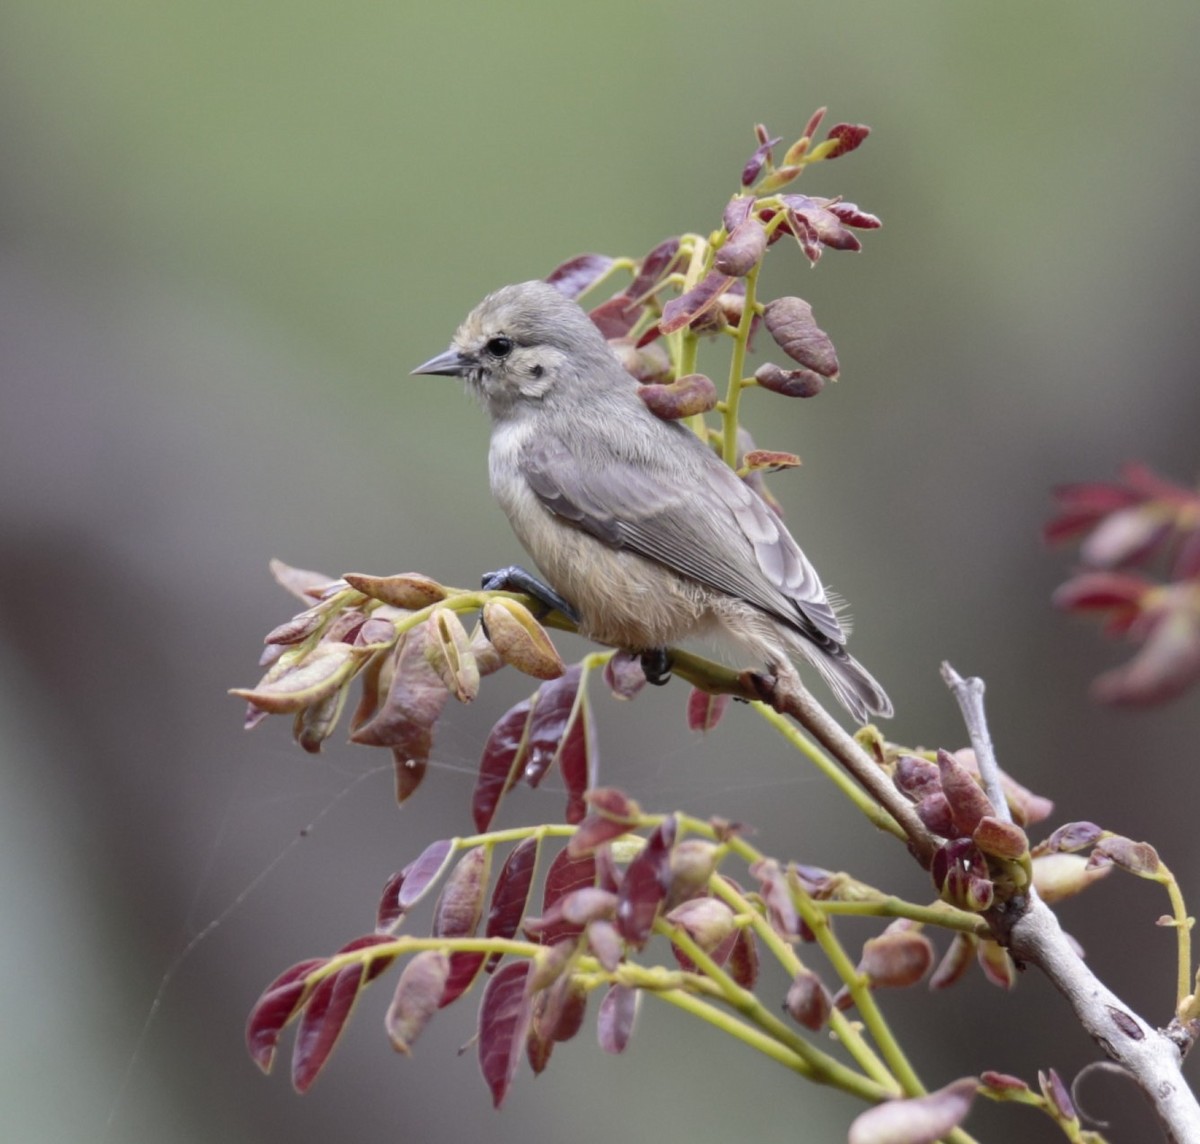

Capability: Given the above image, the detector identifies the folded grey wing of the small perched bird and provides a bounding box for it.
[521,427,846,643]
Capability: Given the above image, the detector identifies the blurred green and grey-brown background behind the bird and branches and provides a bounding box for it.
[0,0,1200,1144]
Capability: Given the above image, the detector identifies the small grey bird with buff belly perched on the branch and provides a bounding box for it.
[413,282,892,723]
